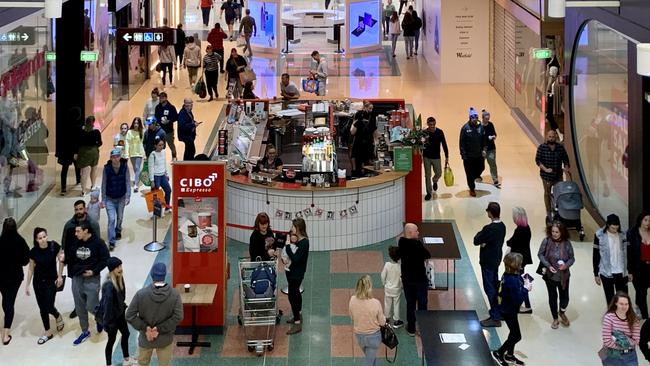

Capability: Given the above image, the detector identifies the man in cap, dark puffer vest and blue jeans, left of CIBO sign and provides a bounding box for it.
[100,149,131,250]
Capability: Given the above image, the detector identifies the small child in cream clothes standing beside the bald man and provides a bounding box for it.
[381,246,404,329]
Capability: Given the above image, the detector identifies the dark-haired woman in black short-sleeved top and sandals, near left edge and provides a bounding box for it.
[25,227,64,344]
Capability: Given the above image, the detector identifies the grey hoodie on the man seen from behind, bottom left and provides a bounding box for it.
[126,284,183,348]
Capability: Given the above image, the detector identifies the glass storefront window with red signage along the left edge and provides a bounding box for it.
[0,11,56,222]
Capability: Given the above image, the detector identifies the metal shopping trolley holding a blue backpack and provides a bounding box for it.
[237,258,282,356]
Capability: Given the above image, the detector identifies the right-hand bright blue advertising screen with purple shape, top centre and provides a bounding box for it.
[348,0,381,48]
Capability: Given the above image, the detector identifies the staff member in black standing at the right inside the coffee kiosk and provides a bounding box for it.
[350,100,377,177]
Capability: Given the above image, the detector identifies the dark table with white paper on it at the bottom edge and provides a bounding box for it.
[415,310,495,366]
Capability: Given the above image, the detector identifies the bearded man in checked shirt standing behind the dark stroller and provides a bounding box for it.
[535,130,569,219]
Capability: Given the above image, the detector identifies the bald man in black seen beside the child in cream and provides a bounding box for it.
[398,223,431,337]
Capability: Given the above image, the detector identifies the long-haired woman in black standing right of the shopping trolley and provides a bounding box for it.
[285,218,309,335]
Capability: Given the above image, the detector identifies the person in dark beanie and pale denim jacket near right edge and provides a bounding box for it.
[593,214,628,304]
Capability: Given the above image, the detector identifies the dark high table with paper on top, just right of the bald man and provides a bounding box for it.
[418,221,461,310]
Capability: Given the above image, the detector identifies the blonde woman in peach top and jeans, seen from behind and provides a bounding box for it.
[348,275,386,366]
